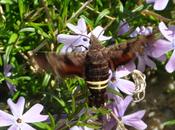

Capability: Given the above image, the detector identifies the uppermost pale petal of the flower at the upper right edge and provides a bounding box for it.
[159,21,173,42]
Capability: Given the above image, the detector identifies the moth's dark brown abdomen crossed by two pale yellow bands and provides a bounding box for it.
[85,50,109,107]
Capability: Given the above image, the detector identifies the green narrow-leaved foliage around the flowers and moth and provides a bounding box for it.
[0,0,174,130]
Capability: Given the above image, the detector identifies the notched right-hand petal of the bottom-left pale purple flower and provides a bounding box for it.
[23,104,48,123]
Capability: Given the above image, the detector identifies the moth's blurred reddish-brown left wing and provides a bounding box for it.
[34,52,86,77]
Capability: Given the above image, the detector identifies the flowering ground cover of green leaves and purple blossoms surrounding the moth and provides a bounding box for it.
[0,0,175,130]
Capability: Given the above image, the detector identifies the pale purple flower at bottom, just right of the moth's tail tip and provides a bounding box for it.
[105,96,147,130]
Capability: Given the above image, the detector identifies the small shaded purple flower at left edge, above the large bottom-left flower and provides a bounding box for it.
[4,64,16,94]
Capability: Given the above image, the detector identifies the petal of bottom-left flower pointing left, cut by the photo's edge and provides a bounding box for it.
[0,110,14,127]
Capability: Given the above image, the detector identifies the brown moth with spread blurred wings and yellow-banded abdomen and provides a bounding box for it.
[34,35,152,107]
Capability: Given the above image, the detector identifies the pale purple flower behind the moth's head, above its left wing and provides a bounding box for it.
[57,18,111,53]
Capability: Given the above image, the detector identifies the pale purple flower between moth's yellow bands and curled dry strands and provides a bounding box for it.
[108,63,135,95]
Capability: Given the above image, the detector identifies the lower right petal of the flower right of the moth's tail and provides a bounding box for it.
[122,110,147,130]
